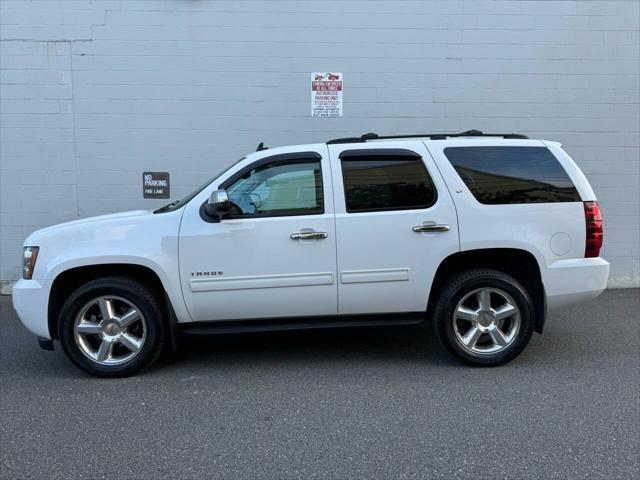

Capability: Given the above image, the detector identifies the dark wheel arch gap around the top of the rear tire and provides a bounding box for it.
[427,248,546,333]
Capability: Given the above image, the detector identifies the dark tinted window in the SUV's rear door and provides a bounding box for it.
[341,155,436,212]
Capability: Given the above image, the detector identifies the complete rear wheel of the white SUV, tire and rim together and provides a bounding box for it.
[433,269,535,366]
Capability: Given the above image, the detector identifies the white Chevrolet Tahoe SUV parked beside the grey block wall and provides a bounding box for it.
[13,130,609,376]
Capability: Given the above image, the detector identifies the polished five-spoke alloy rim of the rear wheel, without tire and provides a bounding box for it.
[453,288,520,355]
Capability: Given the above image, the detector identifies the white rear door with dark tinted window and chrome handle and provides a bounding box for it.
[329,142,459,314]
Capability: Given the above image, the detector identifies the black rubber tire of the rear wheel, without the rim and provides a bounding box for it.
[431,269,535,367]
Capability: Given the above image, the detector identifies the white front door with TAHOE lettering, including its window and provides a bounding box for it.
[180,147,337,321]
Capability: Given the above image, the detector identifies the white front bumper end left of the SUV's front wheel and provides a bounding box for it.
[11,279,51,340]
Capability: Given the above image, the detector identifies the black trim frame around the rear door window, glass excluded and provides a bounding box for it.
[338,148,438,215]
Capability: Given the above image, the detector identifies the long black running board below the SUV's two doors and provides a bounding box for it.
[178,312,425,335]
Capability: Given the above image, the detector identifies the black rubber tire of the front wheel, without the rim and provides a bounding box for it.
[58,277,165,377]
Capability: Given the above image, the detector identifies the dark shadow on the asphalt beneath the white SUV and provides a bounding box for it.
[4,296,616,378]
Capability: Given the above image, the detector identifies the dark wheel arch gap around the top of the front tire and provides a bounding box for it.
[47,263,177,348]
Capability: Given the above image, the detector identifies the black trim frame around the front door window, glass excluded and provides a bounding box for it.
[218,152,325,221]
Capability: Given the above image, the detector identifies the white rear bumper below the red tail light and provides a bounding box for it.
[541,257,609,310]
